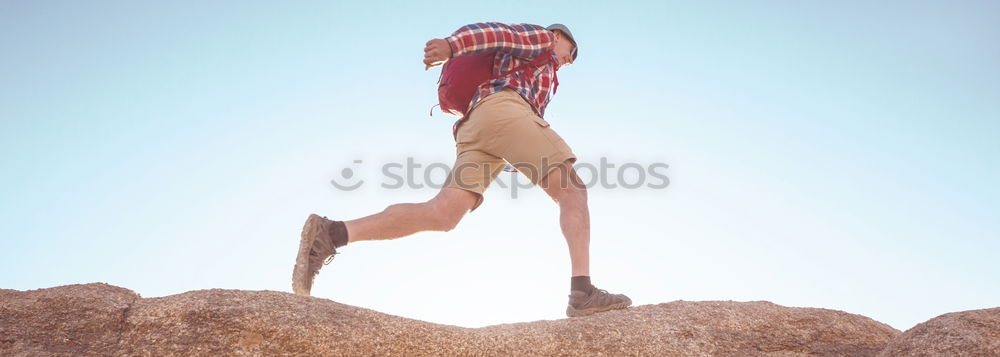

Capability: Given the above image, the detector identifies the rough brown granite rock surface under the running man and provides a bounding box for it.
[0,284,1000,356]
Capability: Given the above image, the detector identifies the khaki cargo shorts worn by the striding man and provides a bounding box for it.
[445,88,576,210]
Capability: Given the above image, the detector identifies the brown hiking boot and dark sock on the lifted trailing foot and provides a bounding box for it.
[292,214,347,296]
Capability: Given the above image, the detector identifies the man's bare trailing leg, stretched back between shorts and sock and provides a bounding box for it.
[344,187,479,243]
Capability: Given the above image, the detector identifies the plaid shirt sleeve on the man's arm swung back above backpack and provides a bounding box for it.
[446,22,555,59]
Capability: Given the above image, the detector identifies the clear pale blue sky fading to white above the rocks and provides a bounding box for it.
[0,0,1000,329]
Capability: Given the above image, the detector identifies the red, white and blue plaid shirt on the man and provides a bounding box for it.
[447,22,559,117]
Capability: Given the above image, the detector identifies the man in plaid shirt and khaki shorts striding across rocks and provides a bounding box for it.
[292,23,632,317]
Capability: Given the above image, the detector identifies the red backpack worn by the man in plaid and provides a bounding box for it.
[438,50,558,119]
